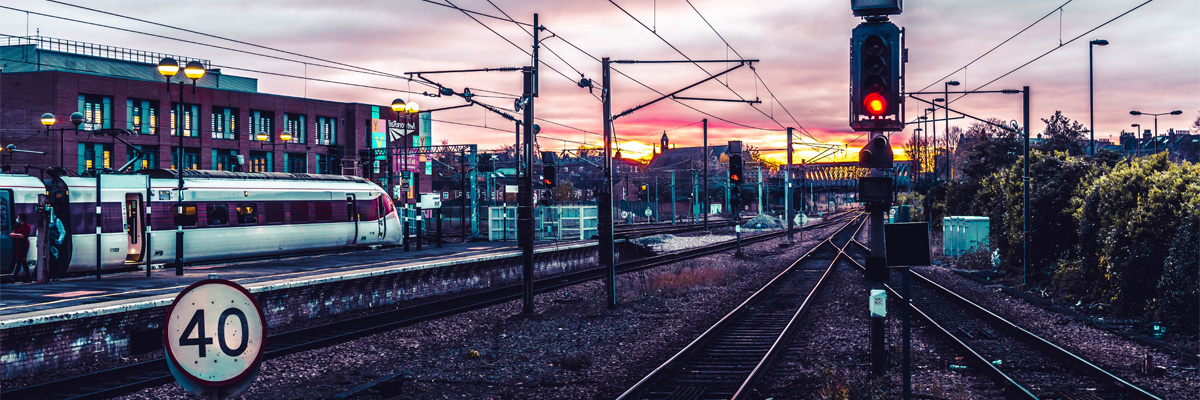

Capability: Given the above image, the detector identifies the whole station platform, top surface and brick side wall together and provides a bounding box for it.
[0,240,599,380]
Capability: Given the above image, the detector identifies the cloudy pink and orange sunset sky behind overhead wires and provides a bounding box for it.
[0,0,1200,161]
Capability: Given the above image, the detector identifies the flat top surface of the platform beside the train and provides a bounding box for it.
[0,237,595,321]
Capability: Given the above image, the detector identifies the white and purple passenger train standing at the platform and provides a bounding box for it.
[0,169,403,276]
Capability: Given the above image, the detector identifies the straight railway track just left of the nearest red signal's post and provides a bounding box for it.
[619,213,863,399]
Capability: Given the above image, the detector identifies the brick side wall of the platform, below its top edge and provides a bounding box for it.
[0,244,599,381]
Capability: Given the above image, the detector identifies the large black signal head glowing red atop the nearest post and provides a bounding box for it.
[850,22,904,131]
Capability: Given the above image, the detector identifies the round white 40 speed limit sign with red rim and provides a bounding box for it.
[162,279,266,398]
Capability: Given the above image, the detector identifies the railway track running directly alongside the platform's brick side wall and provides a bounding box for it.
[0,214,847,400]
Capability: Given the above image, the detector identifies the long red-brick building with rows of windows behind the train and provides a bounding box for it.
[0,36,432,199]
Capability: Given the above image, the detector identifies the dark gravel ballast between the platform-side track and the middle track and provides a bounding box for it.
[117,222,832,399]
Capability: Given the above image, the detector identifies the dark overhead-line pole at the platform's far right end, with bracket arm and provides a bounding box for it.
[598,56,617,310]
